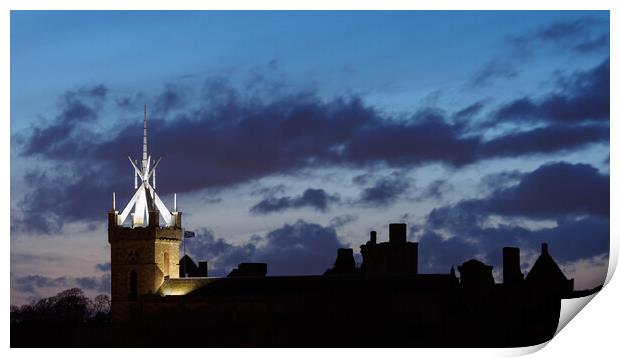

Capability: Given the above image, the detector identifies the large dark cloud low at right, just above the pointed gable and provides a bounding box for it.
[420,162,610,270]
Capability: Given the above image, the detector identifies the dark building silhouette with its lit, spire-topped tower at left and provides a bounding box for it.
[108,111,573,347]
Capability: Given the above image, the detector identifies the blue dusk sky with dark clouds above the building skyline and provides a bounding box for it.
[10,11,610,304]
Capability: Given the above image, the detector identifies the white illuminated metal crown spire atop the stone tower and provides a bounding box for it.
[118,105,175,227]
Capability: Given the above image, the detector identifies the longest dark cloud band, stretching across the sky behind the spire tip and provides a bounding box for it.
[11,60,609,233]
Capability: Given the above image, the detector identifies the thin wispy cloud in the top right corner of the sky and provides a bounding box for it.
[510,17,609,53]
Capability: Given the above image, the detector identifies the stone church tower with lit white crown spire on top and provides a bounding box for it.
[108,106,183,321]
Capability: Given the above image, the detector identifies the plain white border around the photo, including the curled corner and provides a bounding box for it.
[0,0,620,358]
